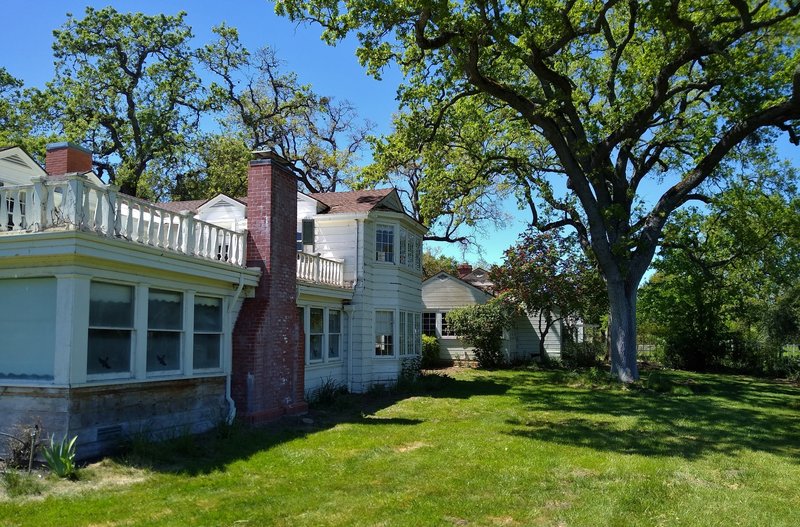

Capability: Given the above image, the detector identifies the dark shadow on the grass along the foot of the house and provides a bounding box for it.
[117,374,511,476]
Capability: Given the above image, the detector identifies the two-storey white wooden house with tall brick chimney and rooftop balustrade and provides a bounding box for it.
[0,143,425,457]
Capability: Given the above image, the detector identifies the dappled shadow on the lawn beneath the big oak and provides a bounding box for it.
[500,372,800,462]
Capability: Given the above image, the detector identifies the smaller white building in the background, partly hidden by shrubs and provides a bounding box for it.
[422,265,564,362]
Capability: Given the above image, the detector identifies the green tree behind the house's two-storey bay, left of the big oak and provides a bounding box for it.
[357,98,522,244]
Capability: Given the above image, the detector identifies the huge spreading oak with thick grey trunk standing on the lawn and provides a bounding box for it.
[276,0,800,382]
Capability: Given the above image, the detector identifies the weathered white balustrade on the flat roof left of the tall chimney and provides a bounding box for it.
[0,176,247,266]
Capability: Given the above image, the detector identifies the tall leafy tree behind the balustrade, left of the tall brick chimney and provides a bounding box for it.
[38,7,203,197]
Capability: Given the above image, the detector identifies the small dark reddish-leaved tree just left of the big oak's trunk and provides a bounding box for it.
[491,231,608,357]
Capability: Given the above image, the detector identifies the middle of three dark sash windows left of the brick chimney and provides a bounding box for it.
[147,289,183,373]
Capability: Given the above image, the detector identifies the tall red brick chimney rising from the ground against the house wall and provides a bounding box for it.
[231,153,308,423]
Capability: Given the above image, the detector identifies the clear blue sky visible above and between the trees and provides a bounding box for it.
[0,0,800,270]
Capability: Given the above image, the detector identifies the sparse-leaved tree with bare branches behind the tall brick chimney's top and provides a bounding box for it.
[198,25,372,192]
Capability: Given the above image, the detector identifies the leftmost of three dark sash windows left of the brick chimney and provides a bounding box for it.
[86,282,134,378]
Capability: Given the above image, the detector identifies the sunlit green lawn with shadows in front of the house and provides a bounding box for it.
[0,370,800,527]
